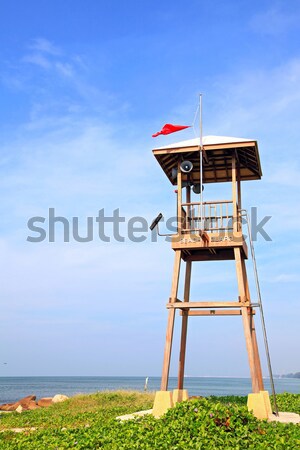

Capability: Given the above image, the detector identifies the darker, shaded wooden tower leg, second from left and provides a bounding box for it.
[178,261,192,389]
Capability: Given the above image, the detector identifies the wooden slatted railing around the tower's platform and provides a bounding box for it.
[181,200,241,233]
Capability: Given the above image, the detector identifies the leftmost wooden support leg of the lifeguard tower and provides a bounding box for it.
[161,250,181,391]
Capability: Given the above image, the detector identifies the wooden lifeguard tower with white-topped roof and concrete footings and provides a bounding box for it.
[152,136,278,418]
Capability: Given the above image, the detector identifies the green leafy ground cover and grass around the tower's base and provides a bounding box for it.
[0,391,300,450]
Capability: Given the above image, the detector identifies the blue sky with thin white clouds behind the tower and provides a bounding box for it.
[0,0,300,376]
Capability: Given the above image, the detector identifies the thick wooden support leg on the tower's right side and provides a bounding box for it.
[234,247,259,393]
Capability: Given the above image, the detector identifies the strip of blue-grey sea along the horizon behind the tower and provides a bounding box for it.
[0,376,300,404]
